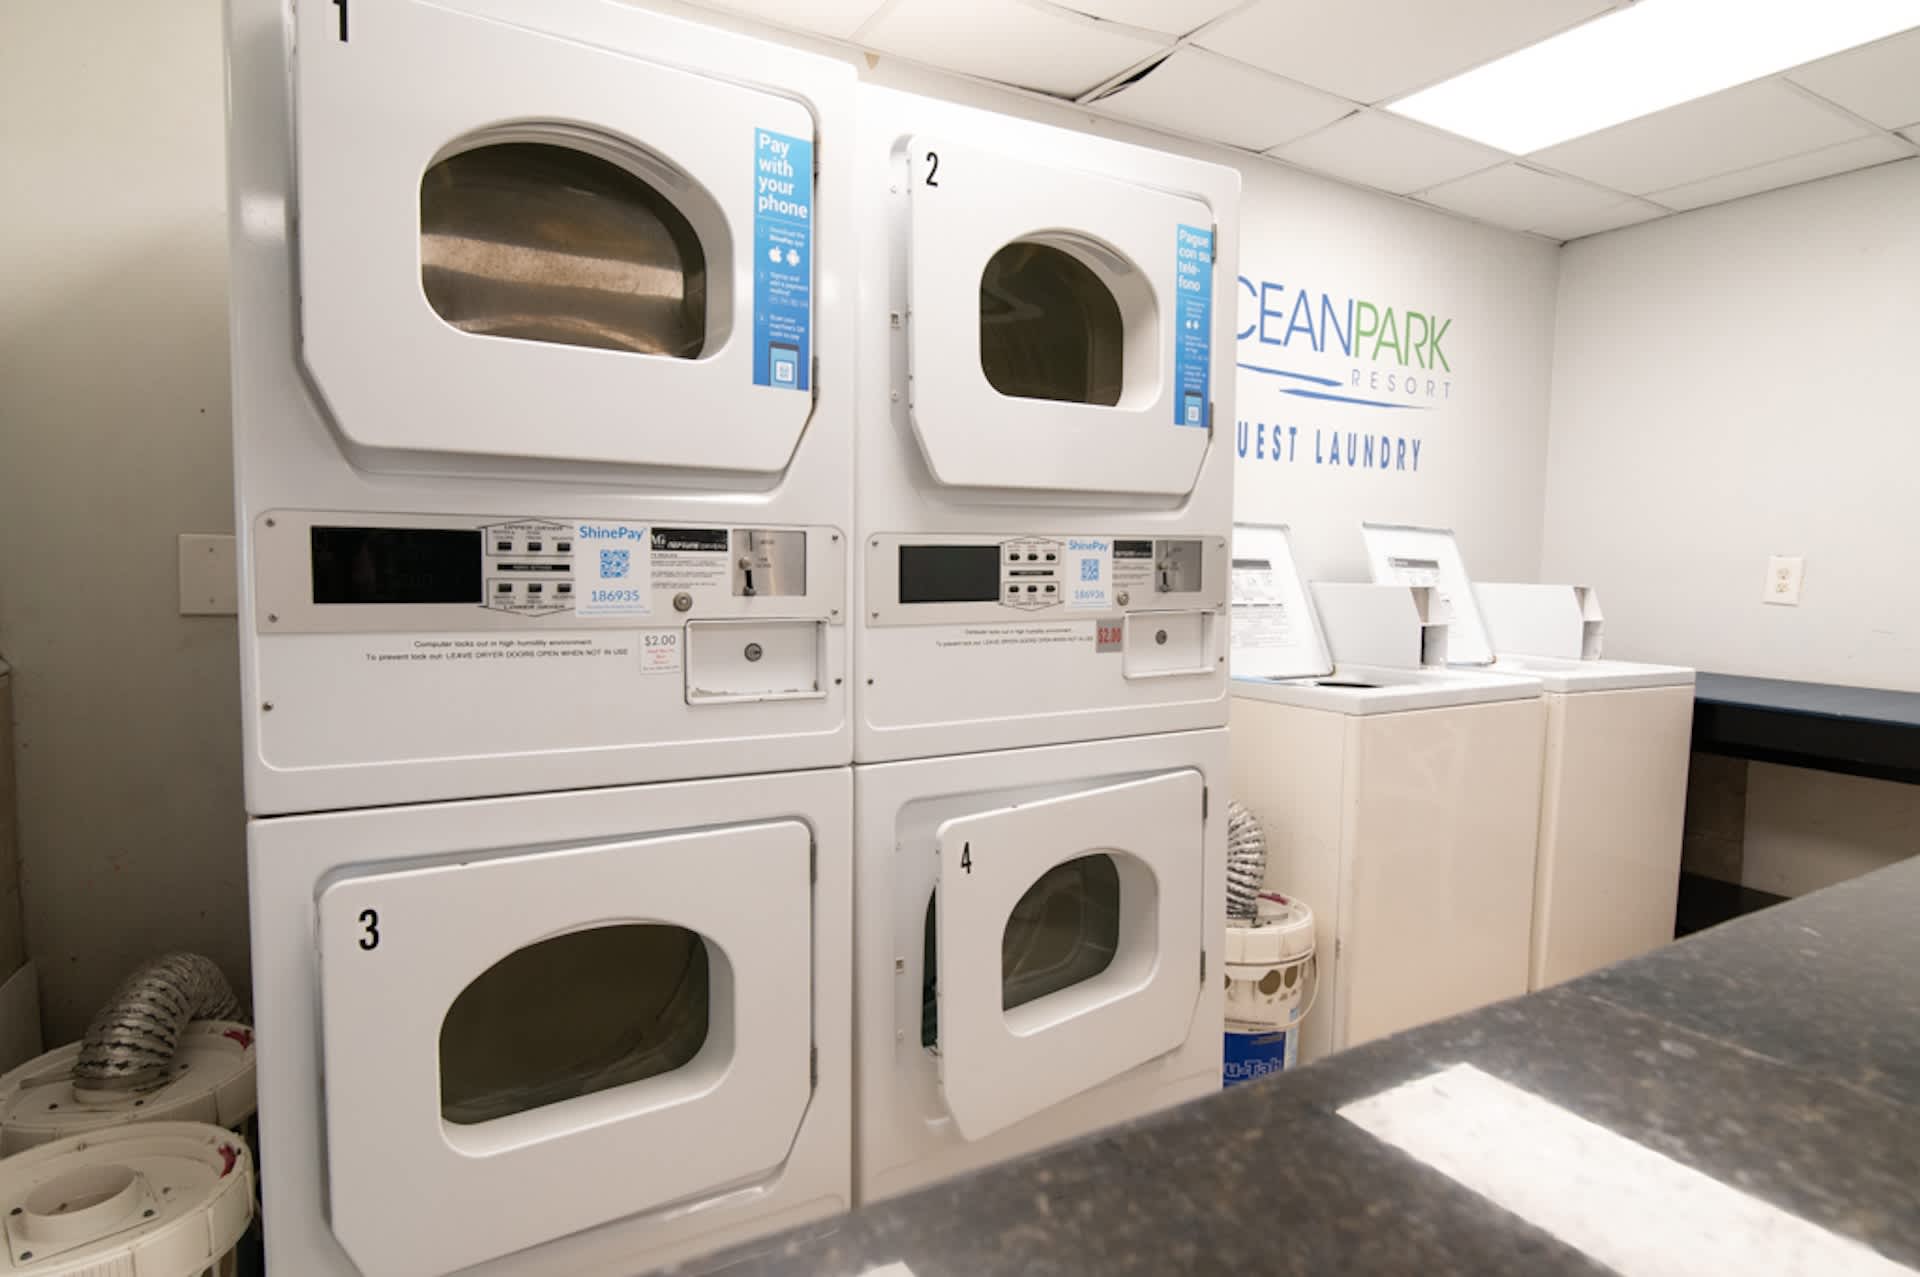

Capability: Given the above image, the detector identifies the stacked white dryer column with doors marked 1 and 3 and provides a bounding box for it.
[228,0,854,1277]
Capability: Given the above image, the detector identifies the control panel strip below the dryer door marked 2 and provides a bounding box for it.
[866,534,1229,626]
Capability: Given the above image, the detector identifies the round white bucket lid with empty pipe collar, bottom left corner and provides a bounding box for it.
[0,1121,253,1277]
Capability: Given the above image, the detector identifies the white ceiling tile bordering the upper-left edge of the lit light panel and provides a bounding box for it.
[1196,0,1613,102]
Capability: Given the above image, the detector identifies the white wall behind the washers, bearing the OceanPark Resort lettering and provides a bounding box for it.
[1235,161,1559,580]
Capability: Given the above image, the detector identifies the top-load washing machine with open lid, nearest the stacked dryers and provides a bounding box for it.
[1233,526,1544,1060]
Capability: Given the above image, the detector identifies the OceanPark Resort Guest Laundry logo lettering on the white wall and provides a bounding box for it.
[1235,275,1453,472]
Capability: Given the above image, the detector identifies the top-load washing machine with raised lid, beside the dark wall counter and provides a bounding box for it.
[1365,524,1693,989]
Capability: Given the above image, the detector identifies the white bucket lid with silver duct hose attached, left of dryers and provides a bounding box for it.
[0,1020,253,1156]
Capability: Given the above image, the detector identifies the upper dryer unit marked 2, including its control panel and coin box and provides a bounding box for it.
[852,86,1240,762]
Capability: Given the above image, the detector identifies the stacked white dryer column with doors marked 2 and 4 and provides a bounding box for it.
[852,86,1238,1200]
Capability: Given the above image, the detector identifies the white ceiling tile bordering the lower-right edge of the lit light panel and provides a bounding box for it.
[1528,81,1866,196]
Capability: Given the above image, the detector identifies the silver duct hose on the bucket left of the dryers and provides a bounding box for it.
[73,952,240,1091]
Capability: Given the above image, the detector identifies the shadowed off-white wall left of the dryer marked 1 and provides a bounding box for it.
[0,0,248,1043]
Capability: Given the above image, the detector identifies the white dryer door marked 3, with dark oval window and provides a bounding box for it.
[319,820,812,1277]
